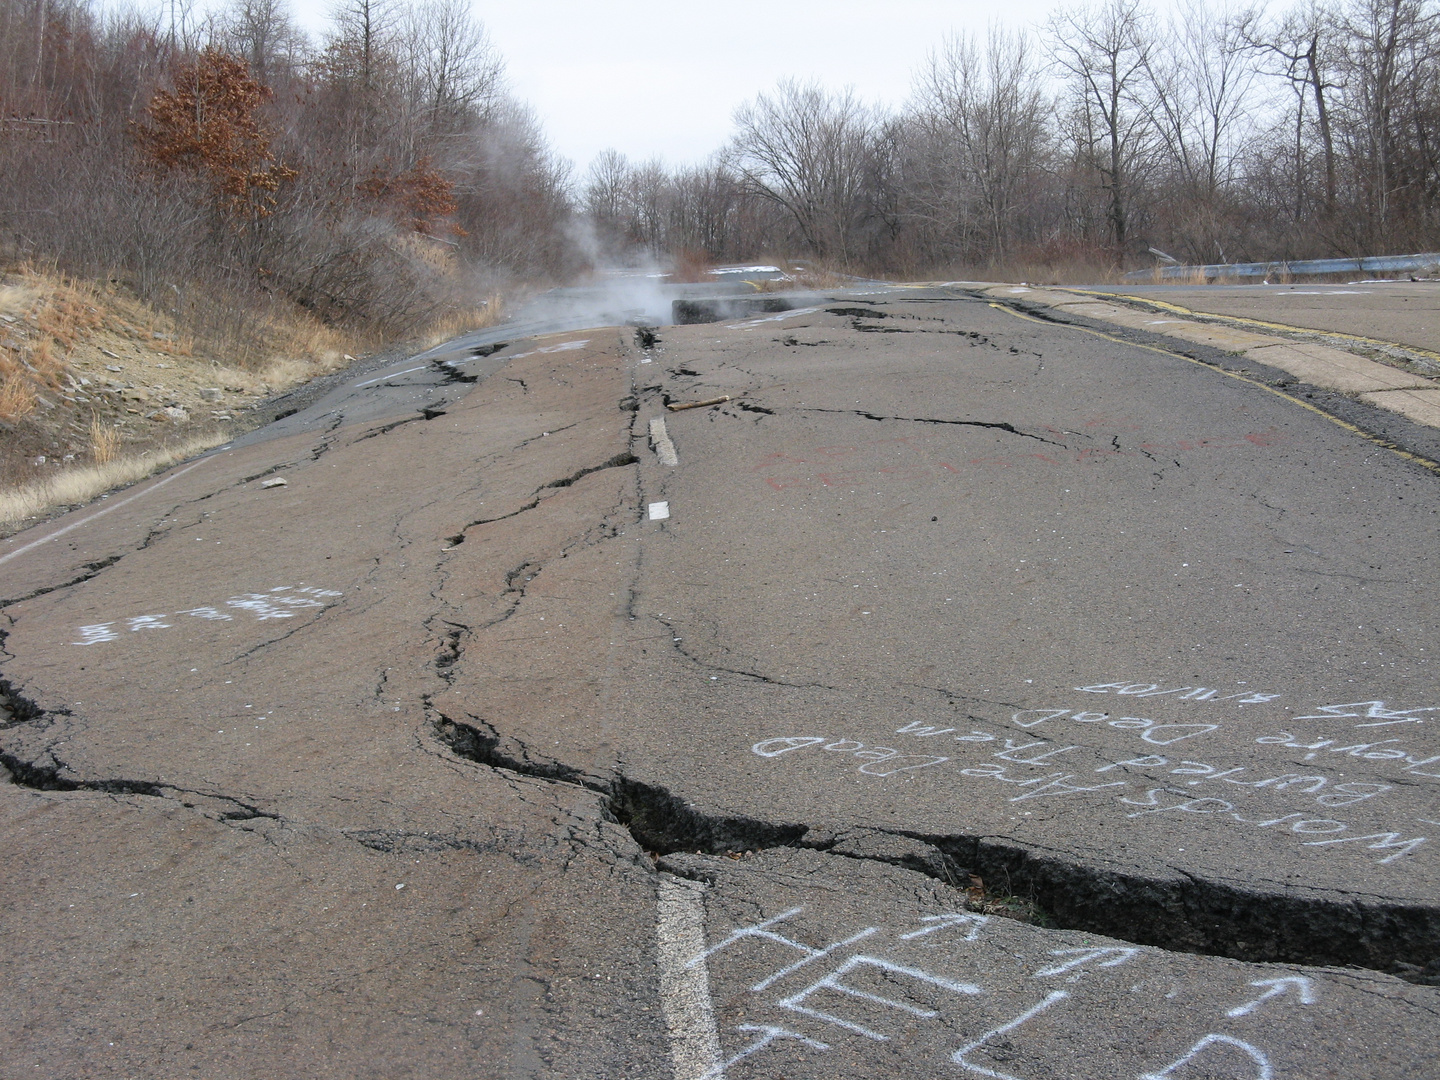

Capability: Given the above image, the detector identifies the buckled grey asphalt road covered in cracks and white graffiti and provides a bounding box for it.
[0,289,1440,1080]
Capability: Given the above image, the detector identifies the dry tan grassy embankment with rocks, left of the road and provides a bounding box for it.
[0,266,501,536]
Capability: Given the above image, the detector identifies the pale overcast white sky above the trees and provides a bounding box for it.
[283,0,1057,173]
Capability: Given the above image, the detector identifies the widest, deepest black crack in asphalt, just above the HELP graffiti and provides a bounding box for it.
[432,711,1440,981]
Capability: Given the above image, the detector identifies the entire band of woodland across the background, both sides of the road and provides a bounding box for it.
[0,0,1440,305]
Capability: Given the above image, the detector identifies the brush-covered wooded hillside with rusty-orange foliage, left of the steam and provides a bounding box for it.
[0,0,573,340]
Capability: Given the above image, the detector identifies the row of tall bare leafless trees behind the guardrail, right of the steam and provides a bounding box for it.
[583,0,1440,274]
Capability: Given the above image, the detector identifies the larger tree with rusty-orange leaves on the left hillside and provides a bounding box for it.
[131,46,295,220]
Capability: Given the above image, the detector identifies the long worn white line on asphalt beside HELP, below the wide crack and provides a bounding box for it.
[657,874,720,1080]
